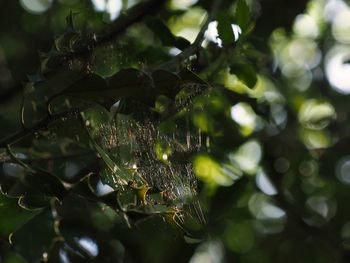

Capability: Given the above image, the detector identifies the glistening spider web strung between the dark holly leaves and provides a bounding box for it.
[86,83,207,228]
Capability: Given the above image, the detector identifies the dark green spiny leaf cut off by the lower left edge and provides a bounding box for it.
[0,192,38,237]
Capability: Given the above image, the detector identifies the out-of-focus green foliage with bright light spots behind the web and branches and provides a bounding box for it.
[0,0,350,263]
